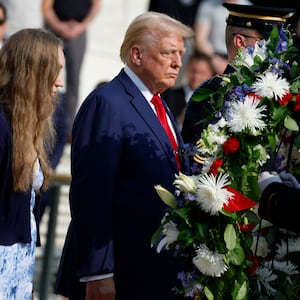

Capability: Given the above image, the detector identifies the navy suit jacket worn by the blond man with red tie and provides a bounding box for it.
[56,70,188,300]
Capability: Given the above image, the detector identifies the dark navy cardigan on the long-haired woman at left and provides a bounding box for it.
[0,105,35,246]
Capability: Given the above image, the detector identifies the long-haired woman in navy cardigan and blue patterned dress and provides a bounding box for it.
[0,29,64,300]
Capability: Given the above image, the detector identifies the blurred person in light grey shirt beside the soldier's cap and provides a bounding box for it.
[195,0,251,74]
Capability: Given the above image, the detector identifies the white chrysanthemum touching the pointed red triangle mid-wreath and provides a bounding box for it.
[196,174,233,215]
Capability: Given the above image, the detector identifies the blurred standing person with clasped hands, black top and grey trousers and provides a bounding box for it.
[42,0,100,133]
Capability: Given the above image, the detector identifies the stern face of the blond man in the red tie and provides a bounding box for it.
[141,33,185,93]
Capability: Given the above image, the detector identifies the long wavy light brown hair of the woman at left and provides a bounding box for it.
[0,29,62,191]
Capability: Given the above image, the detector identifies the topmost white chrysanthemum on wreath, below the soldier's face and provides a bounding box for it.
[251,72,290,100]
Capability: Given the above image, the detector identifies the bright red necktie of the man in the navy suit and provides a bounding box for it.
[151,95,181,170]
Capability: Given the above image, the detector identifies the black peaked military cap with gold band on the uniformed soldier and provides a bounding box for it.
[223,3,296,36]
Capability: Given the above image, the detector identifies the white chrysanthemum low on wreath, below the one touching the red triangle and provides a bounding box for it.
[193,244,228,277]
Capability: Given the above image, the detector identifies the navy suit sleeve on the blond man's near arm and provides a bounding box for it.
[70,94,121,277]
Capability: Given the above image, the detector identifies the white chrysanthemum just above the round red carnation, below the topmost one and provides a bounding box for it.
[228,96,266,135]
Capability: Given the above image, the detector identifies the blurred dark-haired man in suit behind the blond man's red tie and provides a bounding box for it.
[162,51,215,129]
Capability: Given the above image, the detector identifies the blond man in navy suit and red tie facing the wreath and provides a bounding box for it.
[56,12,193,300]
